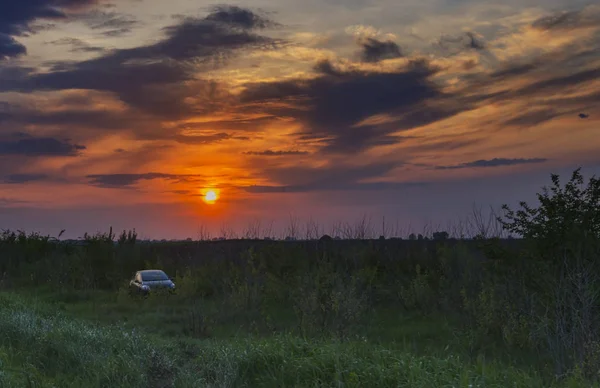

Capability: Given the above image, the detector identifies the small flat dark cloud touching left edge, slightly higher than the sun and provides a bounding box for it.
[0,136,86,156]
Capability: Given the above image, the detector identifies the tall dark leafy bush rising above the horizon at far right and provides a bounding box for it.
[499,169,600,376]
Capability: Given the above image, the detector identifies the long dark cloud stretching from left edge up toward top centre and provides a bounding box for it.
[0,8,276,118]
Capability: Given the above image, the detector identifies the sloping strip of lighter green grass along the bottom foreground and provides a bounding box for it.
[0,293,590,388]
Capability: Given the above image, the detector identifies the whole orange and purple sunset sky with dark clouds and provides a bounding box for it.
[0,0,600,238]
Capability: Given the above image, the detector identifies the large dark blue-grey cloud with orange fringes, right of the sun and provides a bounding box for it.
[241,61,470,153]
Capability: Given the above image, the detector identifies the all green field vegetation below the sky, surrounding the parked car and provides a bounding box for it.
[0,170,600,387]
